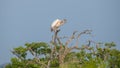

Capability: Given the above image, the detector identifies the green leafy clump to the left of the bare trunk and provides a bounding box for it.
[6,42,51,68]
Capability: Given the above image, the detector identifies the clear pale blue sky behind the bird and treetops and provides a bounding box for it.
[0,0,120,64]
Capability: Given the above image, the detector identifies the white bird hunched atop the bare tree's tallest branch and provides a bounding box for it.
[51,19,66,32]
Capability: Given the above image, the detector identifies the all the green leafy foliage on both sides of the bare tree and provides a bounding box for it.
[6,42,120,68]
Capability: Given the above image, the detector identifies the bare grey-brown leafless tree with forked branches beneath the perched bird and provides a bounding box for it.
[47,30,91,68]
